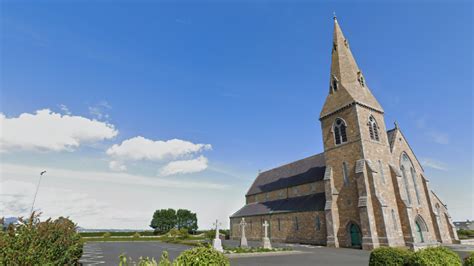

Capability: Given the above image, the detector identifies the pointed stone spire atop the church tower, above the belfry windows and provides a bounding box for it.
[320,17,383,118]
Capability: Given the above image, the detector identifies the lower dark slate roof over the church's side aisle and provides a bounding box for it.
[231,193,326,218]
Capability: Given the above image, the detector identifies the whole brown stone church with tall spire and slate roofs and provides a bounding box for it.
[230,18,458,250]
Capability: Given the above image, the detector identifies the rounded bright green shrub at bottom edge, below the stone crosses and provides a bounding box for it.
[173,246,230,266]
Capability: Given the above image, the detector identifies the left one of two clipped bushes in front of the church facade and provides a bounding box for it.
[369,247,413,266]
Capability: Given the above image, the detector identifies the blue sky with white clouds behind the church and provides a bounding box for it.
[0,1,474,229]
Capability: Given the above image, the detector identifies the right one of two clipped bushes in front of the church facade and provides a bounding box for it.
[408,247,462,266]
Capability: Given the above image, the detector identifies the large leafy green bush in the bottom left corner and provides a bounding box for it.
[0,213,83,265]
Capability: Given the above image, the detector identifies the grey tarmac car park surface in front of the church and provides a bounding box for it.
[80,241,369,266]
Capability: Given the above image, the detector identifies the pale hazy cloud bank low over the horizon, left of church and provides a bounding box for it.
[0,163,234,229]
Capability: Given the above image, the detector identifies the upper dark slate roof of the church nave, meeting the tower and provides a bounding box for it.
[246,153,326,196]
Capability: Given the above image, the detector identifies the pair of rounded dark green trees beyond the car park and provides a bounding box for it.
[150,209,198,233]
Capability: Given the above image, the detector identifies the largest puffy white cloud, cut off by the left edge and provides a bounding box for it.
[0,109,118,151]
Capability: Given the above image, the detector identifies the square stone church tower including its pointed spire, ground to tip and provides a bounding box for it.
[319,17,400,249]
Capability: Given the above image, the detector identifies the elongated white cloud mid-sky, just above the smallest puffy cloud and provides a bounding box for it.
[107,136,212,161]
